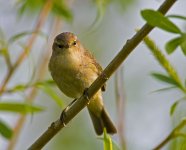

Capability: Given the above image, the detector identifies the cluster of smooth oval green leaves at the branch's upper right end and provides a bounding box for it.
[141,9,186,55]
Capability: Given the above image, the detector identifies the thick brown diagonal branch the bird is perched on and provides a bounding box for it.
[29,0,176,150]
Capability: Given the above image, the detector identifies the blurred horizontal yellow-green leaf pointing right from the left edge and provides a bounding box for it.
[0,102,44,114]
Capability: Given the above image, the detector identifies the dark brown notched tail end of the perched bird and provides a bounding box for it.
[88,108,117,135]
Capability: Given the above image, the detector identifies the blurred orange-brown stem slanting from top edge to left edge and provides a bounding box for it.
[0,0,52,95]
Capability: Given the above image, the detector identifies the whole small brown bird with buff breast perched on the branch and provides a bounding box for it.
[49,32,117,135]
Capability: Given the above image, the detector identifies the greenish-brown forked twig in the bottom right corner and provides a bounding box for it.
[153,119,186,150]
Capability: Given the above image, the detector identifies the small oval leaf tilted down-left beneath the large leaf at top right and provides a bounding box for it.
[165,37,182,54]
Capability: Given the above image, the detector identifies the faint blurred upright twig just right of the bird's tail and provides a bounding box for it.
[115,66,127,150]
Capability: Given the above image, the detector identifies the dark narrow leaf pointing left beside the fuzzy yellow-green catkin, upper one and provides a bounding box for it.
[151,73,178,86]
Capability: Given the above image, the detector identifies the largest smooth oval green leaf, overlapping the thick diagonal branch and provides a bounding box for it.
[141,9,181,33]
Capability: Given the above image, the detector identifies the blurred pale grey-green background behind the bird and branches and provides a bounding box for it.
[0,0,186,150]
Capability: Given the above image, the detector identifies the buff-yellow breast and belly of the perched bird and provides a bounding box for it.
[50,51,97,98]
